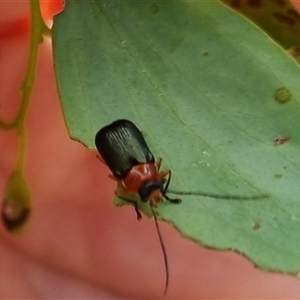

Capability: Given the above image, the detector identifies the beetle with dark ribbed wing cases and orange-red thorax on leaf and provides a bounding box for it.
[95,120,181,213]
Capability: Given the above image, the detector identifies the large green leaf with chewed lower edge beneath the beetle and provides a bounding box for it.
[53,0,300,274]
